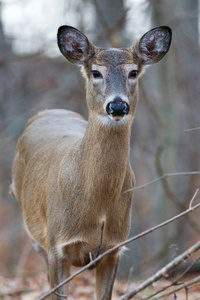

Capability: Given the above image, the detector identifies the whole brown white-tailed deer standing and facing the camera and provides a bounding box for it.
[11,26,171,300]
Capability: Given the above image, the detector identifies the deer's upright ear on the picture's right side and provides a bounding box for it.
[134,26,172,65]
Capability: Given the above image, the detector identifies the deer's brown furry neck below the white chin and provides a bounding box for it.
[79,117,131,204]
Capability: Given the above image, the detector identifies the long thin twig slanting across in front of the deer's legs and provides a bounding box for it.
[38,191,200,300]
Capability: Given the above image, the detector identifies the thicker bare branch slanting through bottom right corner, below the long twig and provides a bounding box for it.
[120,241,200,300]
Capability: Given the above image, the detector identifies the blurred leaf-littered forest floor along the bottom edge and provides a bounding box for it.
[0,271,200,300]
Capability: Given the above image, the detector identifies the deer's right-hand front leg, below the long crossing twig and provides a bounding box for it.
[96,253,119,300]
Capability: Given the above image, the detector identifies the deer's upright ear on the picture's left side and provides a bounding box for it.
[57,26,95,65]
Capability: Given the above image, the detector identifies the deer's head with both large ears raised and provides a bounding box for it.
[58,26,171,126]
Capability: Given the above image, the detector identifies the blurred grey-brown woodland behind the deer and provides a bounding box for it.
[0,0,200,278]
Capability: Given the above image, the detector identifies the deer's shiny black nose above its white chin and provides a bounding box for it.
[106,97,129,117]
